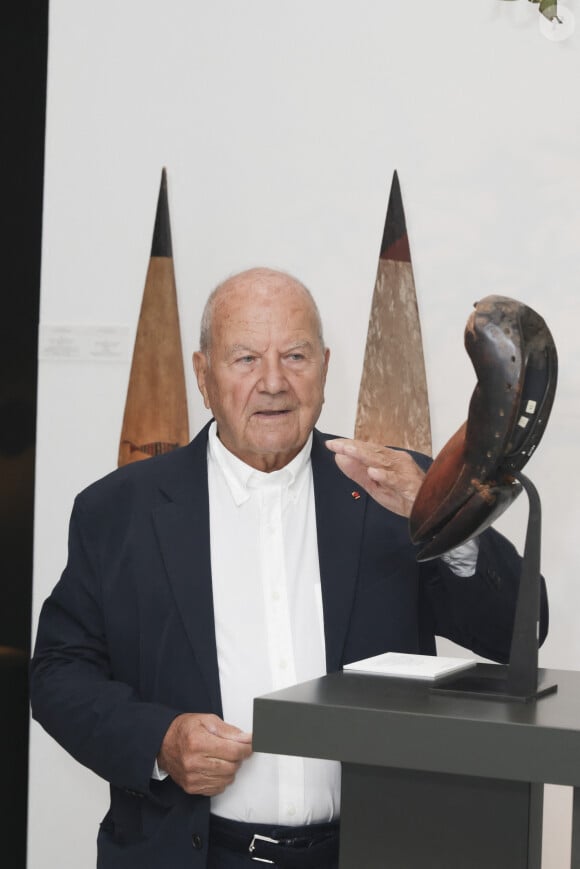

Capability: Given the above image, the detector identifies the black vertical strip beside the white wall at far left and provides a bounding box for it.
[0,0,48,867]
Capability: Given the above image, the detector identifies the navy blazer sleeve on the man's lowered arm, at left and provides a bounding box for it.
[30,499,182,793]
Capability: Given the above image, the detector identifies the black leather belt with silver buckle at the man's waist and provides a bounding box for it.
[210,815,338,869]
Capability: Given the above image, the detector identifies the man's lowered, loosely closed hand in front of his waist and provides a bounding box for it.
[157,713,252,797]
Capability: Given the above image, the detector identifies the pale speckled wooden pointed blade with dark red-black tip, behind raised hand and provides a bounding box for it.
[355,172,431,455]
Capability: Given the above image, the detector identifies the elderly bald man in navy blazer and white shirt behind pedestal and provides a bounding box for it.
[32,269,546,869]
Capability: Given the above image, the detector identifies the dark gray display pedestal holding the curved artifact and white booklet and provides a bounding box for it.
[254,664,580,869]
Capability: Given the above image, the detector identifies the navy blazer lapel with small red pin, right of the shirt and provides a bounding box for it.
[312,429,368,672]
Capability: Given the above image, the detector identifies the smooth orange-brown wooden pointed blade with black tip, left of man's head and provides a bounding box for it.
[118,169,189,466]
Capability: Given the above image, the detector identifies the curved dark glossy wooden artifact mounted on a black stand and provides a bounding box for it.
[409,296,558,561]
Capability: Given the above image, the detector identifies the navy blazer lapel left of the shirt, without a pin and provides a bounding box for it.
[153,426,222,715]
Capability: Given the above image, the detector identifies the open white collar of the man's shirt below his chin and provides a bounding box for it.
[208,420,312,506]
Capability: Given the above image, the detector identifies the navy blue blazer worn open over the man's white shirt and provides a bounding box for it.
[31,426,547,869]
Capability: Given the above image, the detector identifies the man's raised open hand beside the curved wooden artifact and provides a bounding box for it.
[326,438,425,516]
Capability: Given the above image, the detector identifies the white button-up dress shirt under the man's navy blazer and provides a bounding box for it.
[208,423,340,825]
